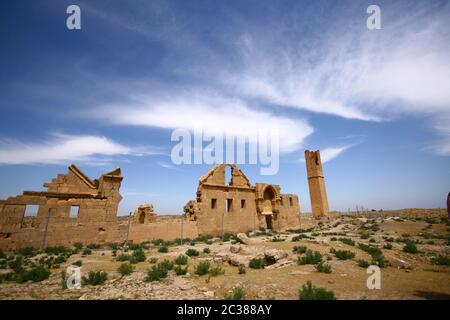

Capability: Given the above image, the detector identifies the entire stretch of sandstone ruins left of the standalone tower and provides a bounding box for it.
[0,164,300,250]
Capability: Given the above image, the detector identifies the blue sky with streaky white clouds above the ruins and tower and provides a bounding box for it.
[0,0,450,214]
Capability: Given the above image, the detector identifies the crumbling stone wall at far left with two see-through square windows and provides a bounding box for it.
[0,165,122,249]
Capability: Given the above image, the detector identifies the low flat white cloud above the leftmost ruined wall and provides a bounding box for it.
[0,134,156,165]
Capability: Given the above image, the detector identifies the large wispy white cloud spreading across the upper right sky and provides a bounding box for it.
[222,6,450,121]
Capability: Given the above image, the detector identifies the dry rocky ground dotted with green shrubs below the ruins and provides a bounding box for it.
[0,209,450,300]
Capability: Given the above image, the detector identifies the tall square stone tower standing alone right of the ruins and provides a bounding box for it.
[305,150,328,218]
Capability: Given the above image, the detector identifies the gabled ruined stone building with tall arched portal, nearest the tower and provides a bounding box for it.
[185,164,300,235]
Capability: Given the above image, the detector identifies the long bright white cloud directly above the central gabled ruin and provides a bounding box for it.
[89,94,313,152]
